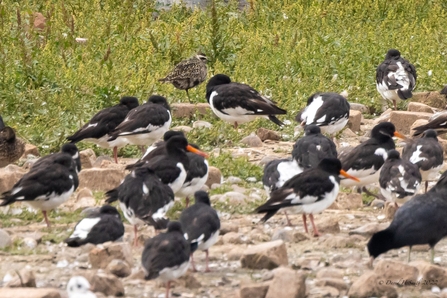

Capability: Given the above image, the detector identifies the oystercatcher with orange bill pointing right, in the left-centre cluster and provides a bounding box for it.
[125,136,208,194]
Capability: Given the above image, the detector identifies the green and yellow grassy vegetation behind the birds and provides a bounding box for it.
[0,0,447,156]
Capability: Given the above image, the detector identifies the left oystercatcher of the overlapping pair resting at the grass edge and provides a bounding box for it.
[67,96,138,163]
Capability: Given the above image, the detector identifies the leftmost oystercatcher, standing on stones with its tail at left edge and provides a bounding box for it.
[0,154,79,227]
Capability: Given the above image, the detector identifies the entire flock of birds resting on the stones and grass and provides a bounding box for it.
[0,49,447,297]
